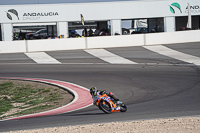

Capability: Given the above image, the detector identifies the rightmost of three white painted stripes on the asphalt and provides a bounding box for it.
[143,45,200,65]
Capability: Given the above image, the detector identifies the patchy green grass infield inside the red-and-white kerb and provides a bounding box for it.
[0,82,62,118]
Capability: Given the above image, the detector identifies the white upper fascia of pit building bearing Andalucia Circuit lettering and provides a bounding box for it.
[0,0,200,23]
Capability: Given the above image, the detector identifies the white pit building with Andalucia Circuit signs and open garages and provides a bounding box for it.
[0,0,200,41]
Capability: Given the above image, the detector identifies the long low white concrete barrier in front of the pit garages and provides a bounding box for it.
[0,30,200,53]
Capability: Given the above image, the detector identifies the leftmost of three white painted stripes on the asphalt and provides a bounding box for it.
[25,52,61,64]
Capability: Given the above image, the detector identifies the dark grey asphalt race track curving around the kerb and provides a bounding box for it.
[0,42,200,132]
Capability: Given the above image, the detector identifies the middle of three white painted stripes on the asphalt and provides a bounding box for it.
[85,49,137,64]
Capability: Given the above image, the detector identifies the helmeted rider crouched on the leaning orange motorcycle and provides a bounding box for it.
[90,87,121,110]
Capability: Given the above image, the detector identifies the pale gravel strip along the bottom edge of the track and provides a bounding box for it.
[3,116,200,133]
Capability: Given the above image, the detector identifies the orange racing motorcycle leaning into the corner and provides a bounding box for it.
[95,94,127,114]
